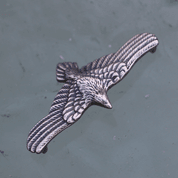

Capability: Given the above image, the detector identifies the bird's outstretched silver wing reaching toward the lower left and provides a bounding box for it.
[27,83,90,153]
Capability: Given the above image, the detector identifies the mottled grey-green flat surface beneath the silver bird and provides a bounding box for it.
[0,0,178,178]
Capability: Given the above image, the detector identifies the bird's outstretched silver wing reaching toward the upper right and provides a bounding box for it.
[81,33,159,88]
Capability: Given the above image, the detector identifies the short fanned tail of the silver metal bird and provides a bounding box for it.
[56,62,79,82]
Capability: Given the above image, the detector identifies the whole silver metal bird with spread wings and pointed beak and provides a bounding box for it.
[27,33,159,153]
